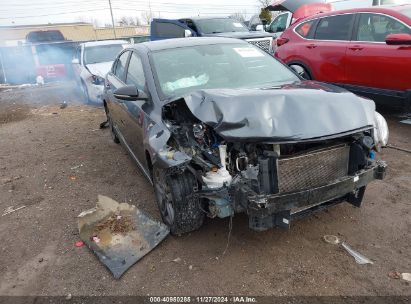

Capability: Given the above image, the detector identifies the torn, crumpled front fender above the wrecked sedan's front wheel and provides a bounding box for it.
[147,123,191,169]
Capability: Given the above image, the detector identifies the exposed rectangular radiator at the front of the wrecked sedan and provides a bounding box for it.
[278,146,350,193]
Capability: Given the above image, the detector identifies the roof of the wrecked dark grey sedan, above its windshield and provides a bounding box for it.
[134,37,248,51]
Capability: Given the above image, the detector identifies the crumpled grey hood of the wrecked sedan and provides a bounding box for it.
[177,81,375,142]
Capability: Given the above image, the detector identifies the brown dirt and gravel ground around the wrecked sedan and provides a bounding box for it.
[0,84,411,296]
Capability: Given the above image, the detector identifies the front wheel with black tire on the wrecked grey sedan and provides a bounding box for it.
[153,168,205,235]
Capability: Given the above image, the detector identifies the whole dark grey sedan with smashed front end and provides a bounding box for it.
[104,38,388,234]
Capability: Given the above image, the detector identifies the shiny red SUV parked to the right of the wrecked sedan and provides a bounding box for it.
[275,5,411,105]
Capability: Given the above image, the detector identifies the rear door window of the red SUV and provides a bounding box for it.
[314,14,354,41]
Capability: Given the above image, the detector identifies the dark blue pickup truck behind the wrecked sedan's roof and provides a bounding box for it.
[151,17,275,54]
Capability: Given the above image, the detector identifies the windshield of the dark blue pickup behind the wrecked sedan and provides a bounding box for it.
[195,18,248,34]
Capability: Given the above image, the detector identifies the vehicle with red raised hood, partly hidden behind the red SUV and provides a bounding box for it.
[266,0,333,37]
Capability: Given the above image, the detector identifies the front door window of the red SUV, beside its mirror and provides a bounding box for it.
[356,14,411,42]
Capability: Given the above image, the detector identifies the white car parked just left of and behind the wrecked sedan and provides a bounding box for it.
[72,40,128,103]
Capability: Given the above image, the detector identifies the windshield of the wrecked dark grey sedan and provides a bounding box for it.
[151,43,299,99]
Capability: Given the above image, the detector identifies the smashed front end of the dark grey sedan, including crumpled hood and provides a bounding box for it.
[153,86,388,231]
